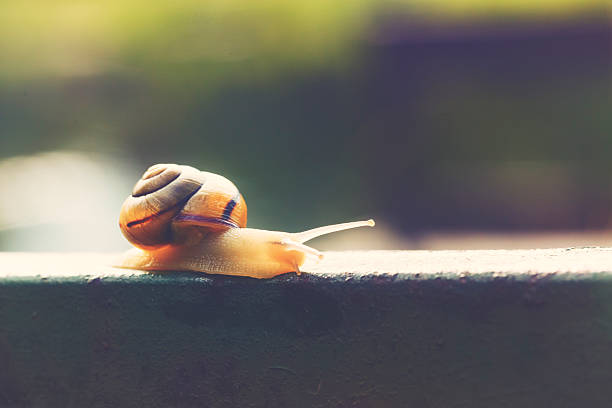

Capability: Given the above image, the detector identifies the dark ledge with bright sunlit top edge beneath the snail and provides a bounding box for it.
[0,248,612,407]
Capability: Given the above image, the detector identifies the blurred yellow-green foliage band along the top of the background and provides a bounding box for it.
[0,0,609,82]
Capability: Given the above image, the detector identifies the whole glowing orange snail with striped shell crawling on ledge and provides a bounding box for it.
[118,164,374,278]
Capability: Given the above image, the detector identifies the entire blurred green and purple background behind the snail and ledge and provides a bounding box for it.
[0,0,612,251]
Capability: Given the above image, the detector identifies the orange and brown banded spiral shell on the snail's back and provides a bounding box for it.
[119,164,247,249]
